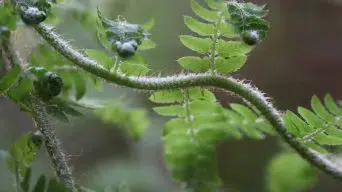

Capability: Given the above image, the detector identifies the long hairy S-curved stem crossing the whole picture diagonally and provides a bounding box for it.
[35,24,342,179]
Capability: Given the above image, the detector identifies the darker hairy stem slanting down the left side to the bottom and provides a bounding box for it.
[1,31,76,192]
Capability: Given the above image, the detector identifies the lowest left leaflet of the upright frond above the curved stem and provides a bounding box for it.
[177,56,210,72]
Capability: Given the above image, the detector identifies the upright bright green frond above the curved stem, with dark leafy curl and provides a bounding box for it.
[177,0,269,74]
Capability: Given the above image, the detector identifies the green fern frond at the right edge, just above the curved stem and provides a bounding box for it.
[283,94,342,153]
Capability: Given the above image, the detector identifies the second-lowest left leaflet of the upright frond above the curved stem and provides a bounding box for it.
[180,35,212,53]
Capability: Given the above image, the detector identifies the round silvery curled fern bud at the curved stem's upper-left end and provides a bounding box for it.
[20,7,47,25]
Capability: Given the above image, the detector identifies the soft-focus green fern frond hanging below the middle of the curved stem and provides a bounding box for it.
[150,87,274,191]
